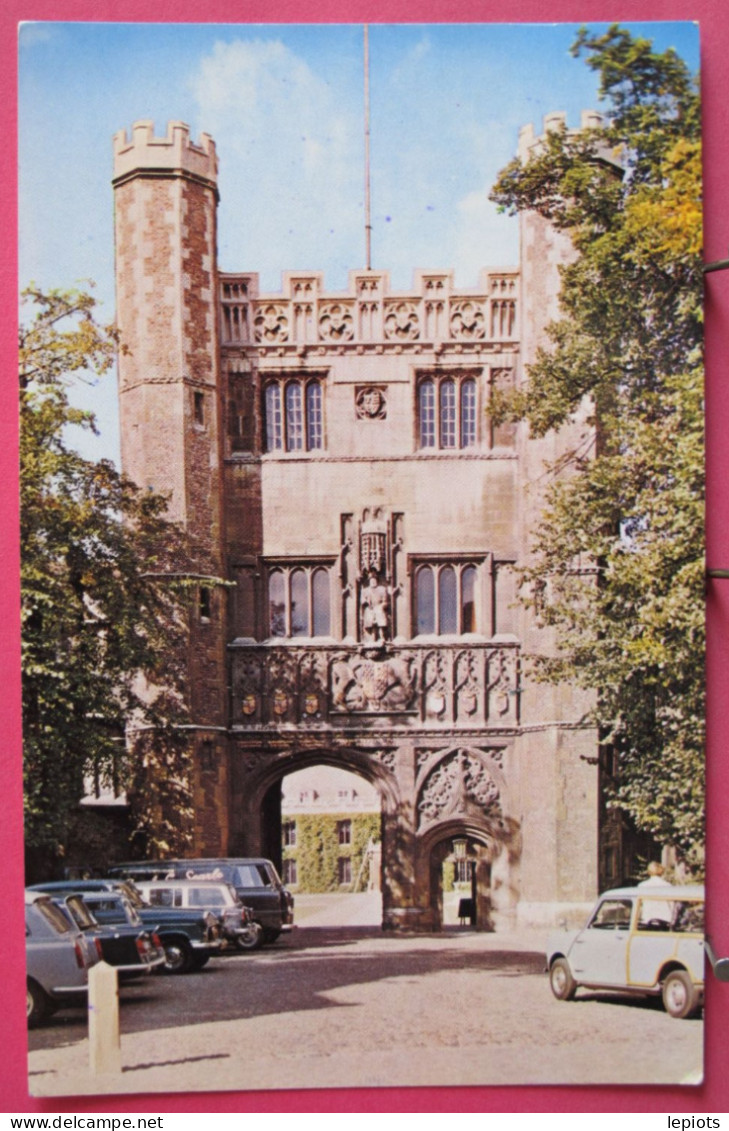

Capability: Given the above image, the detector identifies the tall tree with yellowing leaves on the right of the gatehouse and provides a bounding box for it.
[492,25,704,856]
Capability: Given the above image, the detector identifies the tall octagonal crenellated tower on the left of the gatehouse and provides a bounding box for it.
[113,121,226,852]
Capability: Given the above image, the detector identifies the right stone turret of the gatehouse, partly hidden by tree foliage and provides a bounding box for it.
[510,111,618,906]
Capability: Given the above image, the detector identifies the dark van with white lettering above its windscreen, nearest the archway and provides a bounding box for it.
[109,856,294,943]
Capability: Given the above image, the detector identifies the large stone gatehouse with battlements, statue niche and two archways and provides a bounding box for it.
[113,114,600,930]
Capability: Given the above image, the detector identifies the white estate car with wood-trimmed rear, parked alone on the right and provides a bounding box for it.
[547,883,704,1017]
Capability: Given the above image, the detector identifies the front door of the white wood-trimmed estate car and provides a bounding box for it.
[570,899,633,986]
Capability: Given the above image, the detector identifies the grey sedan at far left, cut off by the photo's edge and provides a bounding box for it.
[25,891,101,1028]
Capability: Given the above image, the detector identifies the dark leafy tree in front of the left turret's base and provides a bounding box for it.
[19,287,190,875]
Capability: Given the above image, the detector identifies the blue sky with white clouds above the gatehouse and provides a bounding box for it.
[19,23,698,458]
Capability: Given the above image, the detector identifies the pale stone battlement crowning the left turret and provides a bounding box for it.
[113,121,218,185]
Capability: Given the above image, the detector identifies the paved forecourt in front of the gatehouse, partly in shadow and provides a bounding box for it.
[29,897,703,1096]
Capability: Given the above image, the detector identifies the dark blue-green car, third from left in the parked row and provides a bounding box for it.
[31,880,222,974]
